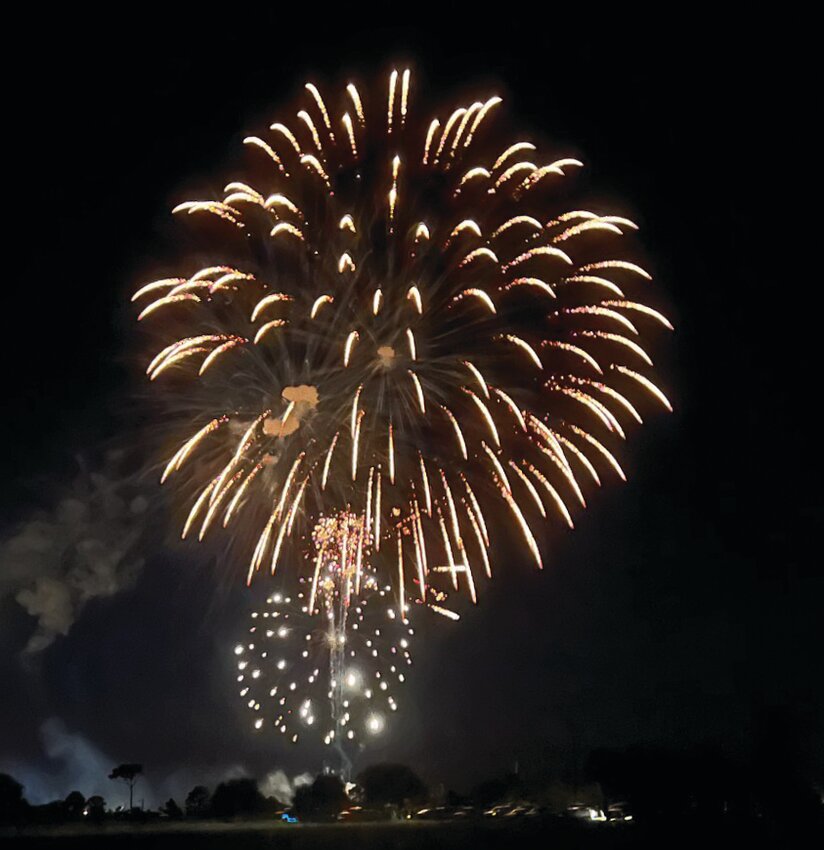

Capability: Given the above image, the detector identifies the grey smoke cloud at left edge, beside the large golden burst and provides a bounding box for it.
[0,452,149,654]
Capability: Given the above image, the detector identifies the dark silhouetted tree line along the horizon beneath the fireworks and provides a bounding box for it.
[0,747,824,826]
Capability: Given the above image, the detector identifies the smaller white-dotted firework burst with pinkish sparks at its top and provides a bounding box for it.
[235,512,414,774]
